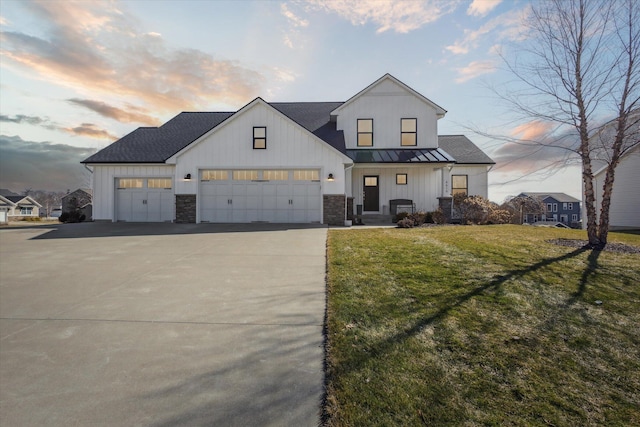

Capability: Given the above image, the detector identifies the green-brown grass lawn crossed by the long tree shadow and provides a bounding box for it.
[325,226,640,426]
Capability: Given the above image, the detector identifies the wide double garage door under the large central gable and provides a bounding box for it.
[199,169,322,223]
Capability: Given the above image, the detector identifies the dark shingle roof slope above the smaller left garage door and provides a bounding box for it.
[82,113,234,163]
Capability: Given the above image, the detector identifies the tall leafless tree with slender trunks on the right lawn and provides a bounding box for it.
[502,0,640,249]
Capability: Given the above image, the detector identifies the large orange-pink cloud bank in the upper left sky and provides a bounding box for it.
[0,1,265,113]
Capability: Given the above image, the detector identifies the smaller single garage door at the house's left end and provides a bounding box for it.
[116,178,175,222]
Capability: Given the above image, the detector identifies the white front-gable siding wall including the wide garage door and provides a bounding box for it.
[169,100,350,222]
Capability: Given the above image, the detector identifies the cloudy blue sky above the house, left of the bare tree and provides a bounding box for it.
[0,0,580,202]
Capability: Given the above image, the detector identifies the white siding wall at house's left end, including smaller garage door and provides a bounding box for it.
[90,164,175,222]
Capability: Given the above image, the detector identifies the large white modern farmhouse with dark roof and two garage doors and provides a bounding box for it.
[83,74,494,225]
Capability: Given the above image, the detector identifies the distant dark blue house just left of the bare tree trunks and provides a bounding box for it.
[520,192,581,228]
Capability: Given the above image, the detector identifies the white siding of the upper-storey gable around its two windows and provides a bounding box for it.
[337,80,438,149]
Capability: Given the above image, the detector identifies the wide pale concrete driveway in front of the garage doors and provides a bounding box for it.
[0,223,327,426]
